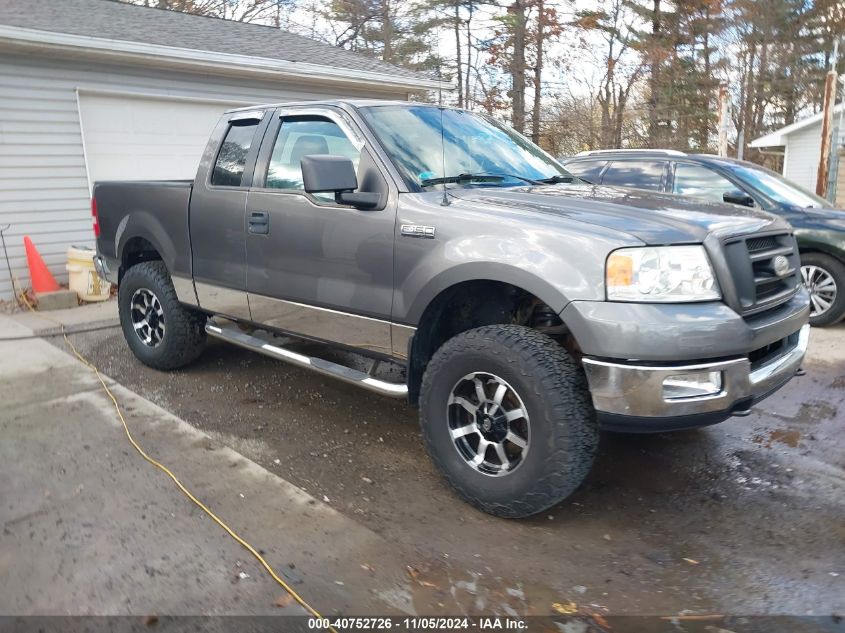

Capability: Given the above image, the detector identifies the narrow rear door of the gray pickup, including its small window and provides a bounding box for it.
[190,110,272,320]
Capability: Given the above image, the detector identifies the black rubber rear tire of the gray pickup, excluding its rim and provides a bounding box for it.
[117,261,206,370]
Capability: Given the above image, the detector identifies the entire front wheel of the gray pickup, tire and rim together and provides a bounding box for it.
[420,325,598,518]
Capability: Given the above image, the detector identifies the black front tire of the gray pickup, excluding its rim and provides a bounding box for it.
[420,325,599,518]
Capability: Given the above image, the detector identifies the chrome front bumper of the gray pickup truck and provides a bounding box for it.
[583,325,810,432]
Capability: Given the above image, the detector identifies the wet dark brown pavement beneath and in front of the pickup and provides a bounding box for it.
[49,325,845,616]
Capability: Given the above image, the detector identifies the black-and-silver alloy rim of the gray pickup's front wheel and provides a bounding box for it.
[446,372,530,477]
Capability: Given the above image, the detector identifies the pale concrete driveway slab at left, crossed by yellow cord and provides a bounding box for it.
[0,316,446,616]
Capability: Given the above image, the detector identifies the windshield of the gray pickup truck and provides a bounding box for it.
[360,105,572,188]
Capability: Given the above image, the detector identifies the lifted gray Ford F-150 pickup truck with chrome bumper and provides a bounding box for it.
[92,101,809,517]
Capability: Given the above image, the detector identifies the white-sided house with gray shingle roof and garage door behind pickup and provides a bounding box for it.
[0,0,441,299]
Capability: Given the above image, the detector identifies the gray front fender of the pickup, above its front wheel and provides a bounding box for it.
[393,192,642,325]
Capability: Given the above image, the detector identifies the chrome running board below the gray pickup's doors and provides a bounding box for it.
[205,322,408,398]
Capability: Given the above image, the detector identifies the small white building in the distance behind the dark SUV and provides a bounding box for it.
[750,103,845,196]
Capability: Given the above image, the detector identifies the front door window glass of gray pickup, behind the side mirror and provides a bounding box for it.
[264,116,360,194]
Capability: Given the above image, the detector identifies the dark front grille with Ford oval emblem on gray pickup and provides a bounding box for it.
[724,233,800,315]
